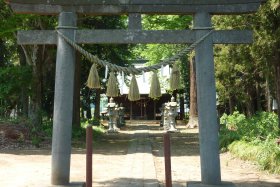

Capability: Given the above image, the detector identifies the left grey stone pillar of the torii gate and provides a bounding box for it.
[51,12,77,185]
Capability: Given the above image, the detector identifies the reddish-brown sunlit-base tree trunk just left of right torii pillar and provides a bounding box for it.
[187,58,198,128]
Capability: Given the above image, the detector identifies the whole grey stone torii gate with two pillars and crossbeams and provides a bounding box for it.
[7,0,266,186]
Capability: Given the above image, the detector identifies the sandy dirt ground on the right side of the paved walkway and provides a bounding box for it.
[150,127,280,187]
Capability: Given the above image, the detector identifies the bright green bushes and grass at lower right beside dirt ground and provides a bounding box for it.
[220,112,280,173]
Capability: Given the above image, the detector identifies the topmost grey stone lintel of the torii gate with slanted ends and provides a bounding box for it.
[6,0,267,15]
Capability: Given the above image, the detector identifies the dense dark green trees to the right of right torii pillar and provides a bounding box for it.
[214,0,280,131]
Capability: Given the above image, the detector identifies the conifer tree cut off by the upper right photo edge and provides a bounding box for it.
[253,0,280,133]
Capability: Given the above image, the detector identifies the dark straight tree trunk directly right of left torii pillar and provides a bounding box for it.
[72,53,81,128]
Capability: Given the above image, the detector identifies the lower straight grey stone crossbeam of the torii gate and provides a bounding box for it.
[18,30,253,45]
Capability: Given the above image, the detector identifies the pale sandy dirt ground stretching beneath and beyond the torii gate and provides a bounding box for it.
[0,122,280,187]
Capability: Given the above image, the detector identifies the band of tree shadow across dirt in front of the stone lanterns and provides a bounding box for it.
[0,124,199,157]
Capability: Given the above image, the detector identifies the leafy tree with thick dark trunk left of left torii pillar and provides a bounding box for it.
[0,0,56,127]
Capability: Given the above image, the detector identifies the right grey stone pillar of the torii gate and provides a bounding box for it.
[194,12,221,184]
